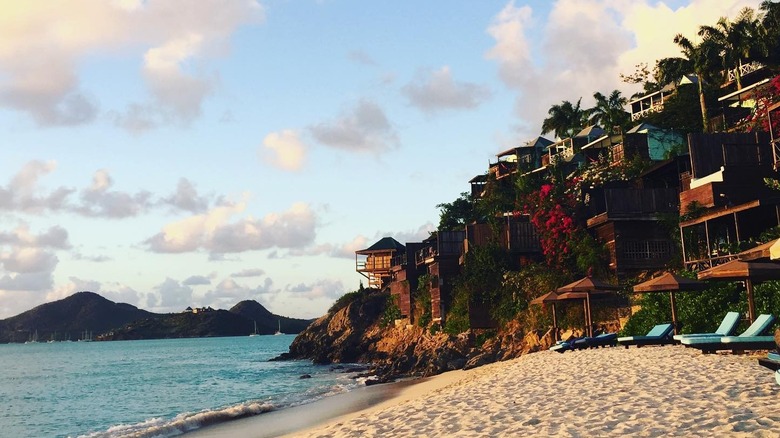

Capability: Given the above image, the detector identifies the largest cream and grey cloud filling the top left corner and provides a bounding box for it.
[0,0,264,126]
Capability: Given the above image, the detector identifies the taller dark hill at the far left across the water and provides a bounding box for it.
[0,292,159,342]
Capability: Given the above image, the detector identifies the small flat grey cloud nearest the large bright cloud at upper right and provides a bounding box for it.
[401,66,490,114]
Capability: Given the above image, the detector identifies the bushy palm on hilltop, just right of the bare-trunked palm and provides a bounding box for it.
[699,7,767,90]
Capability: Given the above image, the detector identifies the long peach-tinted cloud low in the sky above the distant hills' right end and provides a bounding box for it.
[145,202,317,254]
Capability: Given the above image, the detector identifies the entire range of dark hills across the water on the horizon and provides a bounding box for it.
[0,292,312,343]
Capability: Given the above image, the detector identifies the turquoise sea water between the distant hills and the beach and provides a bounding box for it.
[0,335,360,437]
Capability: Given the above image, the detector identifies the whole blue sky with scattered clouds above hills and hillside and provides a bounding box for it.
[0,0,759,318]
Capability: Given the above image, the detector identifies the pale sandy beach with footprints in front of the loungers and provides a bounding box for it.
[290,346,780,437]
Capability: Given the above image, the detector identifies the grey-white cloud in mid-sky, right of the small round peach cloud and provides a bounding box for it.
[309,100,398,154]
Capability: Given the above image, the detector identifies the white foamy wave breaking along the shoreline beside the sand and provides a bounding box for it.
[81,402,275,438]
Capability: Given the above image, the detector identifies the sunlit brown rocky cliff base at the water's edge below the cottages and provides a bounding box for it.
[277,292,552,381]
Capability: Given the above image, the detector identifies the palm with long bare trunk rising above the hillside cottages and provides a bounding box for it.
[656,34,720,132]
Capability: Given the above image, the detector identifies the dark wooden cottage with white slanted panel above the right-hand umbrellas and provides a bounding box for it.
[680,133,780,270]
